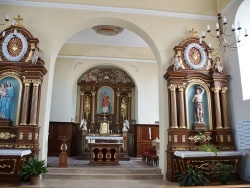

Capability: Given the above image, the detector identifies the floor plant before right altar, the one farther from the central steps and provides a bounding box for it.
[212,162,236,185]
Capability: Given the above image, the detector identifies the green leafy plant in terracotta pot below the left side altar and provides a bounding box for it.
[18,156,48,185]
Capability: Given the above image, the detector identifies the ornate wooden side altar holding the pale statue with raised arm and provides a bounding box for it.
[164,30,239,181]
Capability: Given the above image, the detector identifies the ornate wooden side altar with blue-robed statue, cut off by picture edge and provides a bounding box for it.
[0,16,47,170]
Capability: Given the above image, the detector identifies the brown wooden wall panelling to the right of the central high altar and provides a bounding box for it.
[134,124,159,157]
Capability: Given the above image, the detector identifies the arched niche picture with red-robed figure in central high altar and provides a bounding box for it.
[97,86,114,114]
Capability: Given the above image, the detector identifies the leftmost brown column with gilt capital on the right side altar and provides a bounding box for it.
[168,84,178,129]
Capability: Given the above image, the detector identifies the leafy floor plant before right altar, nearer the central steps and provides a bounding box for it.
[177,165,209,186]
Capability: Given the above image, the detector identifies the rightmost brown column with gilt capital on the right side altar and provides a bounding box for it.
[221,87,230,129]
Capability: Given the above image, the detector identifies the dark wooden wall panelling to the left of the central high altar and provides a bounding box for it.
[48,122,78,157]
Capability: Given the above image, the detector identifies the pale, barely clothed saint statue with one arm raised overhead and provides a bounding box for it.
[192,86,205,123]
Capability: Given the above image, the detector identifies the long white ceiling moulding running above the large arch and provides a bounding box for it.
[0,0,216,21]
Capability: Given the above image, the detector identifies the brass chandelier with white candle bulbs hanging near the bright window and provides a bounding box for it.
[200,0,248,56]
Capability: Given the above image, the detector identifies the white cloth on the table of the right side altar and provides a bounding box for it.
[174,151,245,158]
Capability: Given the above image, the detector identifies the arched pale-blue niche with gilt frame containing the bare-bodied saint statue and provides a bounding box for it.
[186,84,210,130]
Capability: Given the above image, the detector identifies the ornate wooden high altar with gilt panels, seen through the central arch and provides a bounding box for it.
[78,67,134,155]
